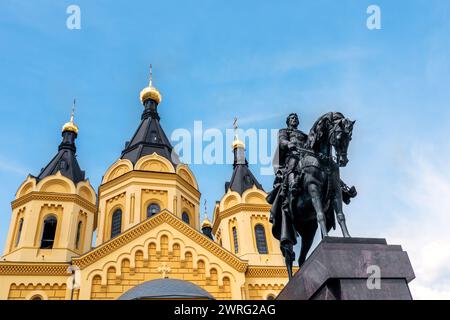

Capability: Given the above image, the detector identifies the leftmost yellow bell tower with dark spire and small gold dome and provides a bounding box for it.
[2,100,96,262]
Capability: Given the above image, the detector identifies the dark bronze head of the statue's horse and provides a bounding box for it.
[329,118,355,167]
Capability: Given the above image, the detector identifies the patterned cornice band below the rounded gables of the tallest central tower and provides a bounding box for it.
[99,170,200,197]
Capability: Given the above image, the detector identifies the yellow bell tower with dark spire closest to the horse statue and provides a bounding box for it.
[212,118,284,266]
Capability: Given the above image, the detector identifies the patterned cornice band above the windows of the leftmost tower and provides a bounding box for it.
[11,191,97,212]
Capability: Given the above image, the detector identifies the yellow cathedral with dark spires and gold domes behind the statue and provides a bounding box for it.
[0,70,288,300]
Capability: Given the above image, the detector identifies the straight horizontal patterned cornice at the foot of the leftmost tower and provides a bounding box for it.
[0,262,69,276]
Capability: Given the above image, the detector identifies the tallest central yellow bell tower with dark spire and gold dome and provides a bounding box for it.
[96,66,200,246]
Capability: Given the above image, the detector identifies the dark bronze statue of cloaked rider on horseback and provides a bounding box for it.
[267,112,357,278]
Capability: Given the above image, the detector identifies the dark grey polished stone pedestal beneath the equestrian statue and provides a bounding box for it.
[277,237,415,300]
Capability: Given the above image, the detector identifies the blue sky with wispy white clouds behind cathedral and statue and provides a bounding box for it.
[0,0,450,298]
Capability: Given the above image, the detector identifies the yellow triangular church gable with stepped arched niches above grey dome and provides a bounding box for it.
[73,210,247,299]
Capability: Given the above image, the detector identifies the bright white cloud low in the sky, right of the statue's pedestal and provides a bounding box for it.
[385,148,450,299]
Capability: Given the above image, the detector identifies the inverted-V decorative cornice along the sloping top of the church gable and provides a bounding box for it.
[72,210,248,272]
